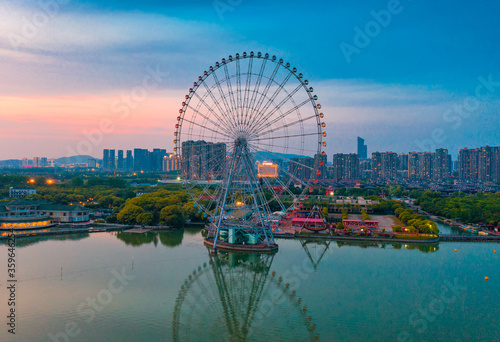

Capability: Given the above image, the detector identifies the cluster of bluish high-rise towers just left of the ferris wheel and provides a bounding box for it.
[101,148,178,172]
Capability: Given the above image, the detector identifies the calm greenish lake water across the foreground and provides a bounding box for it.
[0,230,500,341]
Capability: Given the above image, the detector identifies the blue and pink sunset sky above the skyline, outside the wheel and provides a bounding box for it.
[0,0,500,159]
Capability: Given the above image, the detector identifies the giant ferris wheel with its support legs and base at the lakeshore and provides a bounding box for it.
[174,52,326,248]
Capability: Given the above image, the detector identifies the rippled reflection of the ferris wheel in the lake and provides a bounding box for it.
[172,248,319,341]
